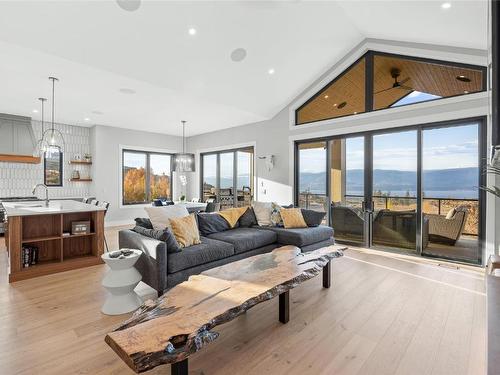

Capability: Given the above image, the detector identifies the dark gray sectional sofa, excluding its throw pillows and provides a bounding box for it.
[118,217,334,296]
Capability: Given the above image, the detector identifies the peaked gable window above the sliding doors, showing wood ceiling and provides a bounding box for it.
[295,51,486,125]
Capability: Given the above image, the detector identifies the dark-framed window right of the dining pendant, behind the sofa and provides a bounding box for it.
[200,147,254,209]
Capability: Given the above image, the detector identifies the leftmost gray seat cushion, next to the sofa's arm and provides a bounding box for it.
[167,237,234,273]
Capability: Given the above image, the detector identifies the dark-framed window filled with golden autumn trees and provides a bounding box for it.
[122,150,172,205]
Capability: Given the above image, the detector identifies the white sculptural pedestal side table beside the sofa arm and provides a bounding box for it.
[101,250,142,315]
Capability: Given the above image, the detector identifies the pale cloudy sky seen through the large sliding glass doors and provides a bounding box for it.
[300,124,479,173]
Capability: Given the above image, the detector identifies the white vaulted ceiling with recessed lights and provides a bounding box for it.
[0,0,487,135]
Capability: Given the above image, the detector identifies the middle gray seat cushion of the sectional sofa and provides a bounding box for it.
[208,228,277,254]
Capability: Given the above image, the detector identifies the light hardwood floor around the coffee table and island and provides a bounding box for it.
[0,229,486,375]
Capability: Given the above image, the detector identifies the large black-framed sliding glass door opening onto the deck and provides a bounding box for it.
[296,119,486,264]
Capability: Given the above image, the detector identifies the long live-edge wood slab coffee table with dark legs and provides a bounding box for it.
[105,245,346,375]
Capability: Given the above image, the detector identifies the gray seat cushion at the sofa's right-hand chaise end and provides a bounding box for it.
[258,225,333,247]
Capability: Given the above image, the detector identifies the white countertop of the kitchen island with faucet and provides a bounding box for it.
[2,200,106,217]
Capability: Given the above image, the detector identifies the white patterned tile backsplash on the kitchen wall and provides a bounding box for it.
[0,120,93,198]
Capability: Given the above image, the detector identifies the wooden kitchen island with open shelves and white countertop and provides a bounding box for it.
[3,200,105,282]
